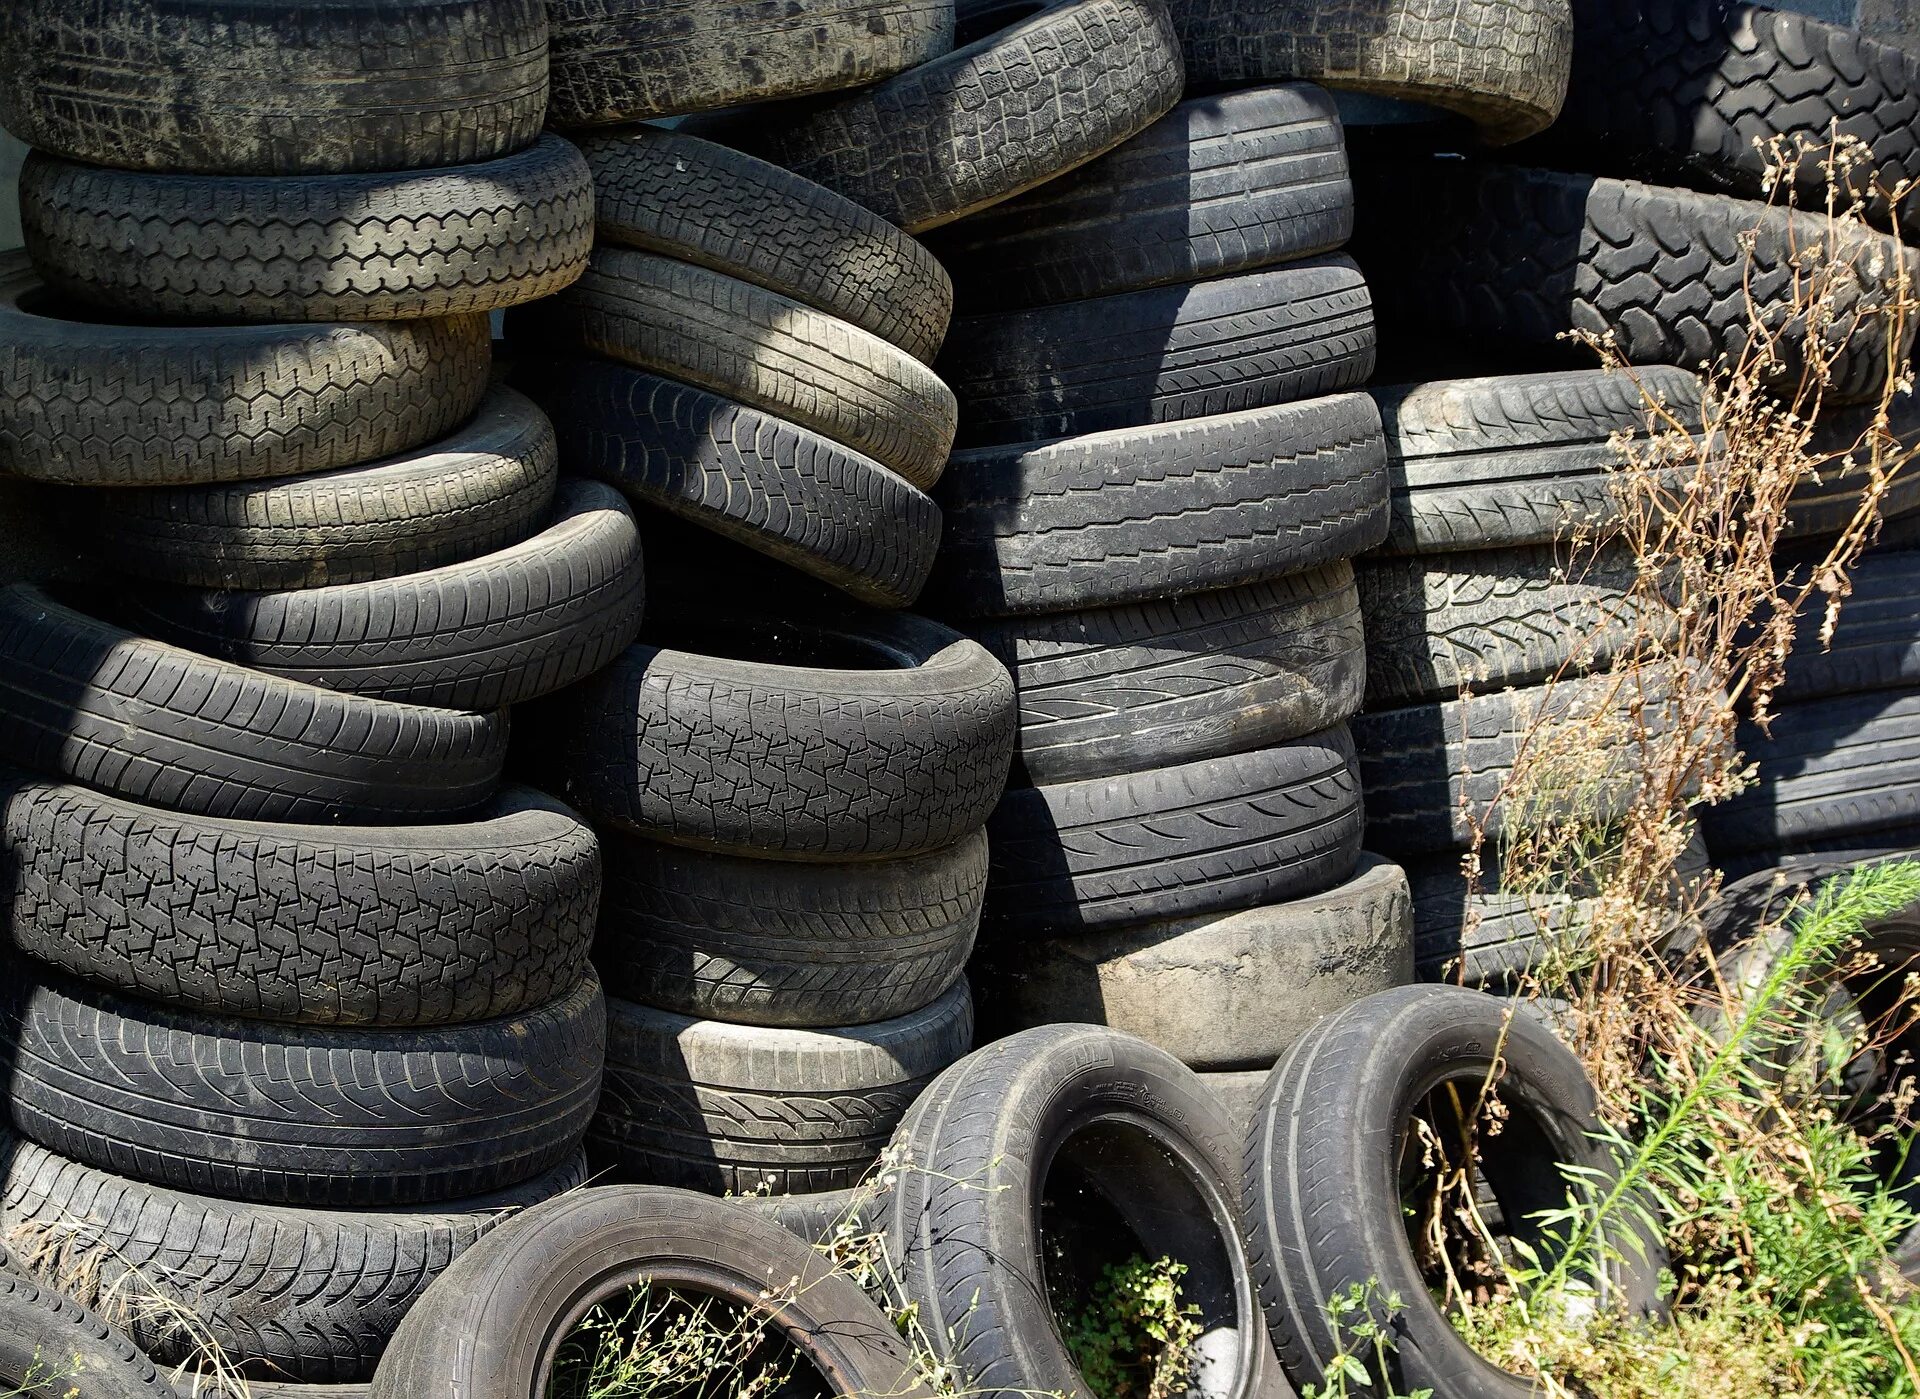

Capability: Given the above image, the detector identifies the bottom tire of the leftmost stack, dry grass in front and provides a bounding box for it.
[0,1142,588,1399]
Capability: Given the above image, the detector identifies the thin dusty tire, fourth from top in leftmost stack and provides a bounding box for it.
[92,388,559,591]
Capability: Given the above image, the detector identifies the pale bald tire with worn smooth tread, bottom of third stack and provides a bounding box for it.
[970,854,1413,1069]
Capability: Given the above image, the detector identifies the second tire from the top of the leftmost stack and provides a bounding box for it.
[19,136,593,322]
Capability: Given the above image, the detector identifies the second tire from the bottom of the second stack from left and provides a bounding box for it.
[593,831,987,1029]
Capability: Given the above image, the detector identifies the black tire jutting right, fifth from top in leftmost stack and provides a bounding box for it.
[129,480,647,710]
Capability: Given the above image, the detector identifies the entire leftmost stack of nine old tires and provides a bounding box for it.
[0,0,643,1382]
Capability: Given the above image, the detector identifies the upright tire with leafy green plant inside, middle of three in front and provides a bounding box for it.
[874,1025,1288,1399]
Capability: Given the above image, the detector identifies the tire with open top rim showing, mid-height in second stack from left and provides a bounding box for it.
[526,612,1018,860]
